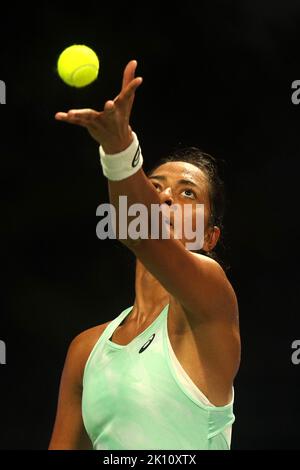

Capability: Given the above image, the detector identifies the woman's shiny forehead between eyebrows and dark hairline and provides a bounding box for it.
[151,162,207,187]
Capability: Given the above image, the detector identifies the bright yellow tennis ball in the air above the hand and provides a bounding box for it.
[57,44,99,88]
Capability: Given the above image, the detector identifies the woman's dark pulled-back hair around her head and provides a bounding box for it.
[147,147,228,269]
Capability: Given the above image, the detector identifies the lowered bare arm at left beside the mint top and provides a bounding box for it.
[49,328,97,450]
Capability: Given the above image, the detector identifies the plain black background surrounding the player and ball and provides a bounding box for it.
[0,0,300,449]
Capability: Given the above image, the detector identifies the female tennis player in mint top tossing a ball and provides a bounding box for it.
[49,60,240,450]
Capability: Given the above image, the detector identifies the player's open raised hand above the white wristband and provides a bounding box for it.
[55,60,143,154]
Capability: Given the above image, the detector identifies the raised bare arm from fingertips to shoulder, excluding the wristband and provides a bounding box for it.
[56,61,237,323]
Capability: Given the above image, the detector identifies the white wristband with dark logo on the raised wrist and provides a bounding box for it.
[99,132,143,181]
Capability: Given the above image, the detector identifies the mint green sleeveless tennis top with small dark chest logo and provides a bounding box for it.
[82,304,235,450]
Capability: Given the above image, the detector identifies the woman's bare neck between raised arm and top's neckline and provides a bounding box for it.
[130,259,170,324]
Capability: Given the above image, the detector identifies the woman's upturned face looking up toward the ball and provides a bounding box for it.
[148,162,220,251]
